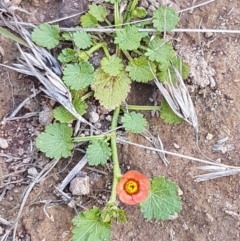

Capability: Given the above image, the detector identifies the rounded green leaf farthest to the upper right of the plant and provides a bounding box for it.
[153,7,179,32]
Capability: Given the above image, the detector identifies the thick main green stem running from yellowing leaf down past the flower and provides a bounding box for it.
[108,107,122,204]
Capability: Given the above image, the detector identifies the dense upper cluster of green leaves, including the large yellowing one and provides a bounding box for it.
[32,4,189,109]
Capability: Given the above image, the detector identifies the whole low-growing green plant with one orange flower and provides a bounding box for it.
[32,0,189,241]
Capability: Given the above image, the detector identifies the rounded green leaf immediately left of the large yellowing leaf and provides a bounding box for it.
[63,62,94,90]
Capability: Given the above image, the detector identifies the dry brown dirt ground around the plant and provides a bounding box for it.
[0,0,240,241]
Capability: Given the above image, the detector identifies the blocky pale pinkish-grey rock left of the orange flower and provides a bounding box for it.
[69,176,90,195]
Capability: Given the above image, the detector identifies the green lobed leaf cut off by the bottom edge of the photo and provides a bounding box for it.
[72,206,111,241]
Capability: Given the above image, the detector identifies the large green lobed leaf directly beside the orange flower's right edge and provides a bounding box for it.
[140,177,182,221]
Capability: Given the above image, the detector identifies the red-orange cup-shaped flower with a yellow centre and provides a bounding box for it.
[117,171,150,205]
